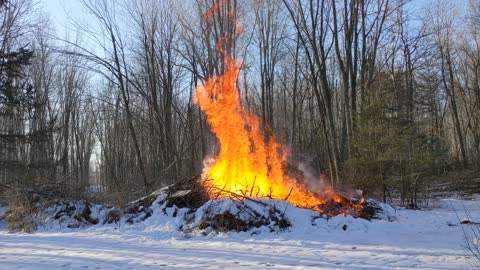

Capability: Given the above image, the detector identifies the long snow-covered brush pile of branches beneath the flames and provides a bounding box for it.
[0,177,395,235]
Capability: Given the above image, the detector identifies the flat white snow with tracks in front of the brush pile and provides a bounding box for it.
[0,199,480,269]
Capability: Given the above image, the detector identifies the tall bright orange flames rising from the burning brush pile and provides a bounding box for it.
[195,1,362,214]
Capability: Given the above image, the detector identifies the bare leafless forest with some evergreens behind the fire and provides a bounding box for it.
[0,0,480,205]
